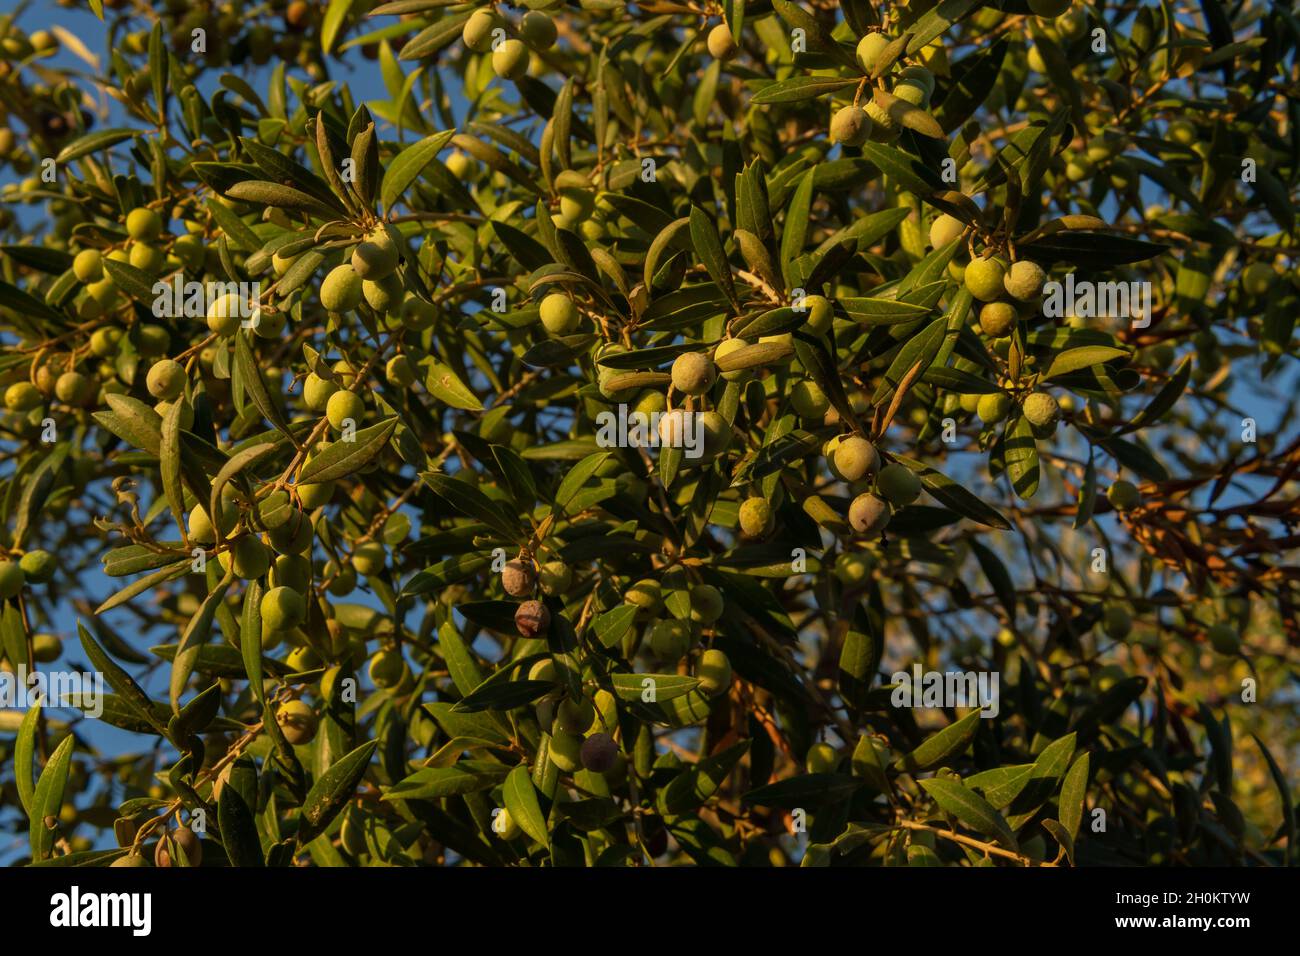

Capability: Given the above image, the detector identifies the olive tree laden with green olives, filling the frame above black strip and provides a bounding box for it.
[0,0,1300,866]
